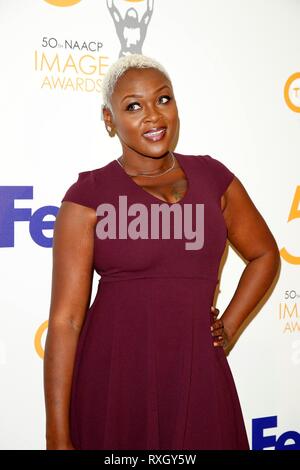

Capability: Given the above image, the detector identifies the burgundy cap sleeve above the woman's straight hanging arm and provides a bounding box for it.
[61,170,97,210]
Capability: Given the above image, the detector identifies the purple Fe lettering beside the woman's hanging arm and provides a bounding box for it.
[0,186,58,248]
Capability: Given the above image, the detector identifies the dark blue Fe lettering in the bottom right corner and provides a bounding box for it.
[252,416,300,450]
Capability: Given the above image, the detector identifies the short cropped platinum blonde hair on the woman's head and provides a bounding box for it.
[102,54,171,110]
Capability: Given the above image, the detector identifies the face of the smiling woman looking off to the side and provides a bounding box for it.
[104,68,179,157]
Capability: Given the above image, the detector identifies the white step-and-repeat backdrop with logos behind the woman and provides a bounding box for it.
[0,0,300,449]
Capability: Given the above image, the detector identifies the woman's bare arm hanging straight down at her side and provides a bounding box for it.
[44,201,96,450]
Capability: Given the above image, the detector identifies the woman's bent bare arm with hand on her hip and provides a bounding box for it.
[214,177,280,345]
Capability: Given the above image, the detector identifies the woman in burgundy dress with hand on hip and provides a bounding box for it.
[45,54,279,450]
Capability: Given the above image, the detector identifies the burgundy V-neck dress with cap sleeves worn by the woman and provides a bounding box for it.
[62,153,249,450]
